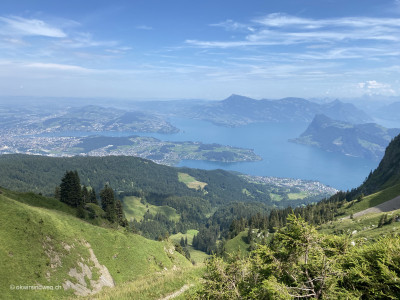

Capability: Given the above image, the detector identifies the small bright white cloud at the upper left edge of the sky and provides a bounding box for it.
[0,16,67,38]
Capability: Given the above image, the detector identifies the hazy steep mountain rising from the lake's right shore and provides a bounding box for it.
[290,114,400,160]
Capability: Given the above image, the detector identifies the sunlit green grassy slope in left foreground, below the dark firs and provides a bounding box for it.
[0,192,191,299]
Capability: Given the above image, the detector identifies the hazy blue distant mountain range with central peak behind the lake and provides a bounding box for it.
[173,95,372,126]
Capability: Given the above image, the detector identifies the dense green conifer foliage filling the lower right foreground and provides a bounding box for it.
[196,215,400,299]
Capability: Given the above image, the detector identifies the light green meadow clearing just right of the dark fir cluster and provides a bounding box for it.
[122,196,180,222]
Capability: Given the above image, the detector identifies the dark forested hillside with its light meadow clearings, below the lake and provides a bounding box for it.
[0,155,335,243]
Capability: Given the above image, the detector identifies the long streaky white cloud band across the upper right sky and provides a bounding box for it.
[185,13,400,48]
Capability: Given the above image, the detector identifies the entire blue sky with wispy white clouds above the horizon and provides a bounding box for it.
[0,0,400,99]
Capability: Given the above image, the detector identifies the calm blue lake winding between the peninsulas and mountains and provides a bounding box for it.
[43,118,379,190]
